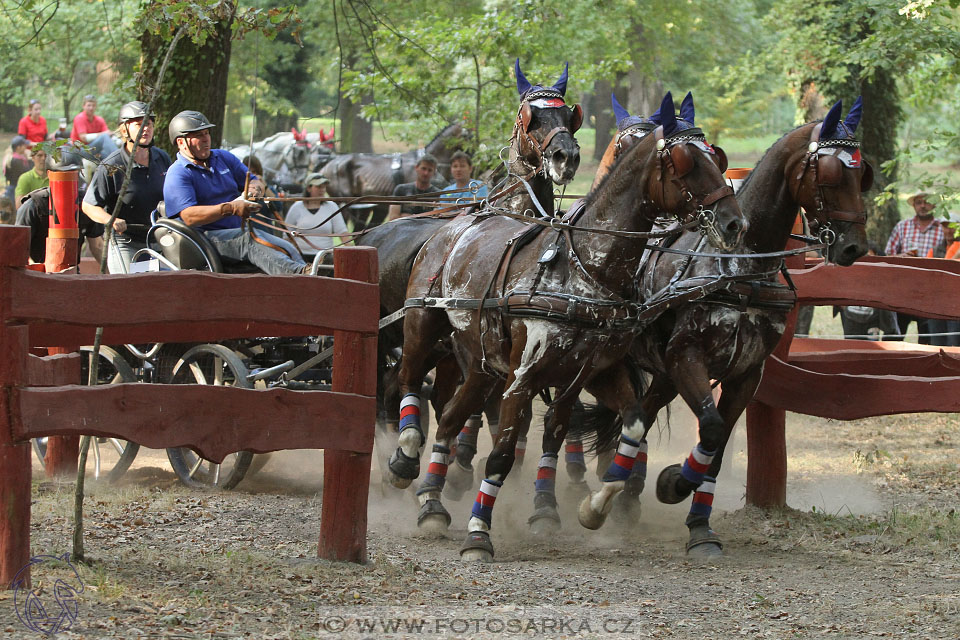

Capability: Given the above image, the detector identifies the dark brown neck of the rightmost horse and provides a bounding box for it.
[737,136,805,253]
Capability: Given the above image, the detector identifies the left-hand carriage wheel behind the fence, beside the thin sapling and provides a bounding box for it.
[33,346,140,482]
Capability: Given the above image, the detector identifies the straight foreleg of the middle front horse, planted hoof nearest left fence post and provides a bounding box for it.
[460,378,534,562]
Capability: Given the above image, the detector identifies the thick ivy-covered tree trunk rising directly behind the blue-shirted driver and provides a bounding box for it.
[137,21,231,156]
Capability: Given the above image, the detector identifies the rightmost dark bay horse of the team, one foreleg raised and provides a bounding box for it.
[572,98,873,556]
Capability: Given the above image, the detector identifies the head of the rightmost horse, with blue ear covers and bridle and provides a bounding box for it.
[785,97,873,266]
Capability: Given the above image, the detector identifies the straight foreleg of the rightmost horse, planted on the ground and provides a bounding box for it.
[686,367,763,558]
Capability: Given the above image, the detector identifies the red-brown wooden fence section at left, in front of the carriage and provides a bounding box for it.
[0,225,379,584]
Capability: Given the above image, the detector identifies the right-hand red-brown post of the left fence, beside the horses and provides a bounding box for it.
[317,247,379,563]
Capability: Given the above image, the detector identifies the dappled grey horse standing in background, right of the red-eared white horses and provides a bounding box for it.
[320,123,468,226]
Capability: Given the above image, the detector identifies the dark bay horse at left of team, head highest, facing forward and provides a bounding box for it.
[356,60,583,452]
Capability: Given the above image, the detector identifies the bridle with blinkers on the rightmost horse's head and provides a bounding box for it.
[790,123,873,246]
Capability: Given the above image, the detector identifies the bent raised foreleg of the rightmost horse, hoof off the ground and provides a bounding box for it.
[657,348,724,516]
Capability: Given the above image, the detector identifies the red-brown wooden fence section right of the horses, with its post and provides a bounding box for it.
[746,257,960,506]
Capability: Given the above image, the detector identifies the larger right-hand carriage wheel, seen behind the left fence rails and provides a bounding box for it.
[167,344,253,489]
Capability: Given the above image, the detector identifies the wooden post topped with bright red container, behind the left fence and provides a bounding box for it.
[44,171,80,477]
